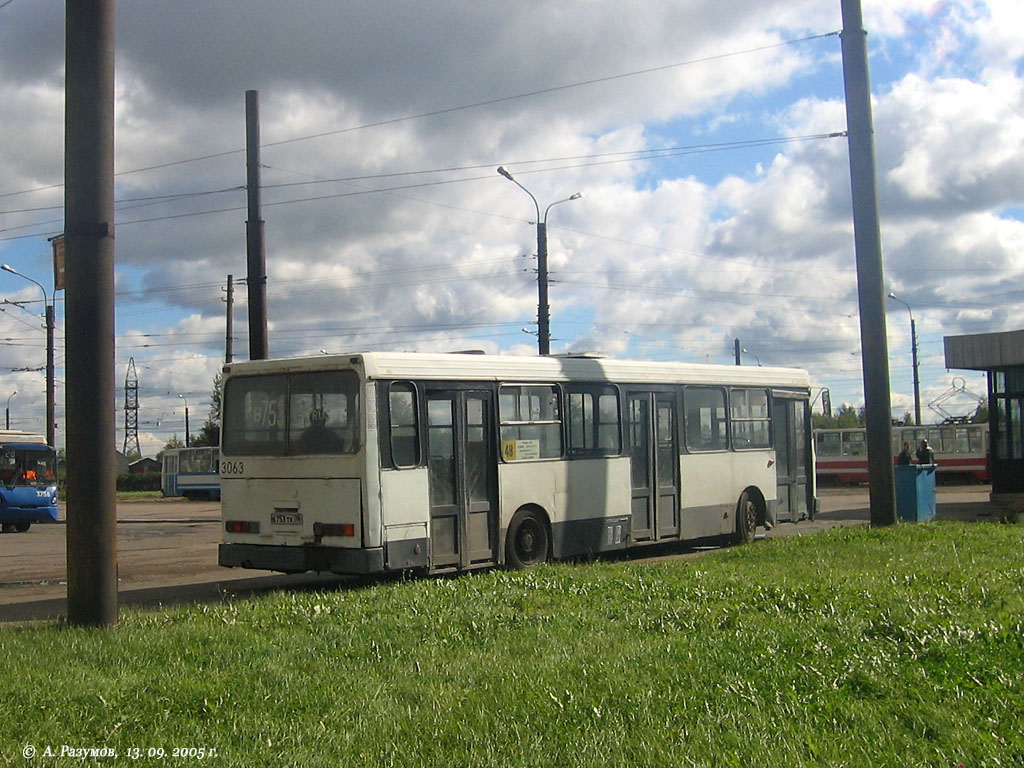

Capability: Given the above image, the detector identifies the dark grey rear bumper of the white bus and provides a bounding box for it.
[217,544,384,573]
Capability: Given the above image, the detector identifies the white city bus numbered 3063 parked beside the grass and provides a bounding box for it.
[219,352,815,573]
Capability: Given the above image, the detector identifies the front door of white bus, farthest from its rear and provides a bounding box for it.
[772,397,810,522]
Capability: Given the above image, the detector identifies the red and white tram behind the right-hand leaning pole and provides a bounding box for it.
[814,424,989,484]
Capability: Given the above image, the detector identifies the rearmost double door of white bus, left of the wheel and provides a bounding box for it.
[427,391,498,568]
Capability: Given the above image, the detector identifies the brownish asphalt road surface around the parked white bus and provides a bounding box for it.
[0,485,995,623]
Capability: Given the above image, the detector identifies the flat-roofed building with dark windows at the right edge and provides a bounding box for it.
[943,331,1024,503]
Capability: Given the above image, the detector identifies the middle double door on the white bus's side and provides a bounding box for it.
[626,392,679,542]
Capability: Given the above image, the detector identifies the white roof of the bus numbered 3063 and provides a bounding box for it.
[224,352,810,389]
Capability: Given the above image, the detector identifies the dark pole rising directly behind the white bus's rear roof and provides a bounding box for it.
[246,91,269,360]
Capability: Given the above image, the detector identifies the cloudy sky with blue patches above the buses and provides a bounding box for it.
[0,0,1024,455]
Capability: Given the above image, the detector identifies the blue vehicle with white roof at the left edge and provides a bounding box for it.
[0,430,57,534]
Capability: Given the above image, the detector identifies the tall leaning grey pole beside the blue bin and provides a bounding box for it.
[842,0,896,525]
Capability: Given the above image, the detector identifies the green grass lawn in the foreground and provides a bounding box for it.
[0,523,1024,768]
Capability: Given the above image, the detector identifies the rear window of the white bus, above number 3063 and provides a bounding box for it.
[223,371,358,457]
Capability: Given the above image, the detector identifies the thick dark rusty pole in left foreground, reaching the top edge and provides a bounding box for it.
[65,0,118,626]
